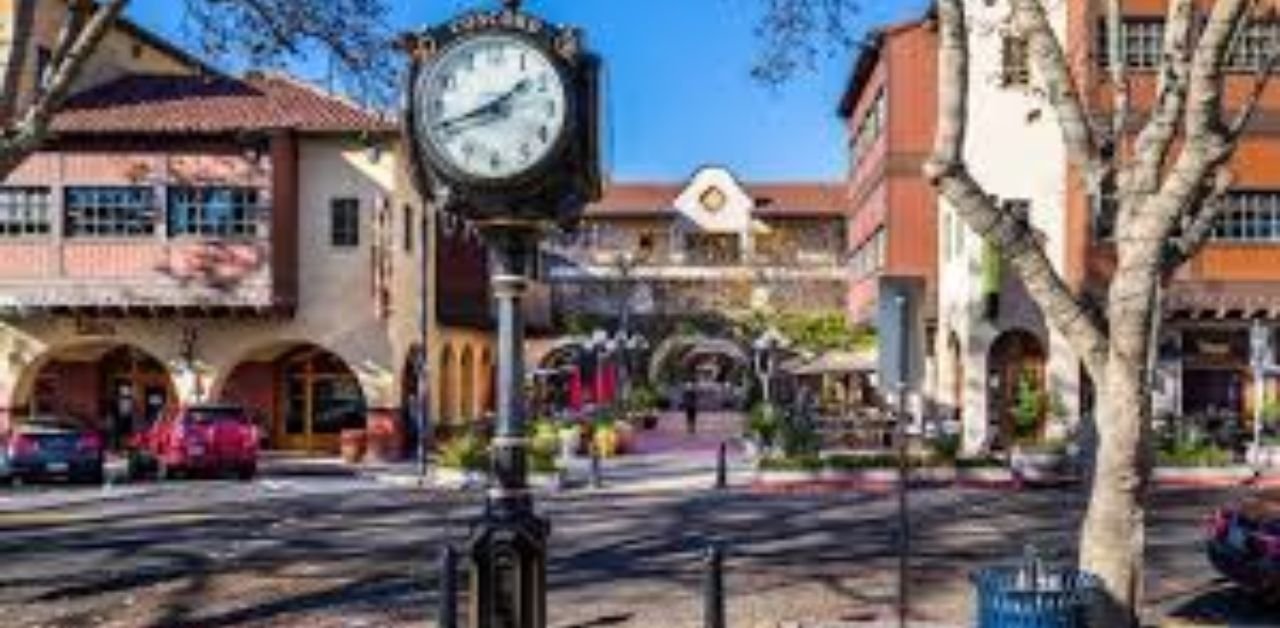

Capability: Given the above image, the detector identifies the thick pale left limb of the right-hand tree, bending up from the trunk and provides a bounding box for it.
[925,0,1107,379]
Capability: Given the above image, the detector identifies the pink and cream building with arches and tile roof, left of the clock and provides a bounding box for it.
[0,1,493,457]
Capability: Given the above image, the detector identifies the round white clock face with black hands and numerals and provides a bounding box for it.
[415,35,567,182]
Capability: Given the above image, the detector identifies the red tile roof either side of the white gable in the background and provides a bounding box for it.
[588,183,847,217]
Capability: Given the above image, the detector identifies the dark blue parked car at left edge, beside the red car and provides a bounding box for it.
[0,414,105,483]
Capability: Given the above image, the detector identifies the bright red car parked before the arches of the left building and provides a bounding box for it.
[129,405,259,480]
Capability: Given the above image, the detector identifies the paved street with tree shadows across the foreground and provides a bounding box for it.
[0,468,1280,628]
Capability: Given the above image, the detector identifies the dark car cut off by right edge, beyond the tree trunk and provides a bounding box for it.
[1206,498,1280,600]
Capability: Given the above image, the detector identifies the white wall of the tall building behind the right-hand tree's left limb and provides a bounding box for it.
[936,0,1079,453]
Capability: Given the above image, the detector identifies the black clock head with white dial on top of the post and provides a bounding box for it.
[404,4,602,225]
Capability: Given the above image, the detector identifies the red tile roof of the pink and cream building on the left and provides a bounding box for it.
[52,74,396,134]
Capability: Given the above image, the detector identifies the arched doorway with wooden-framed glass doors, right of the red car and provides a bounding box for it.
[221,343,367,453]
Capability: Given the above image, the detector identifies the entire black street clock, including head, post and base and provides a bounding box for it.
[402,0,603,628]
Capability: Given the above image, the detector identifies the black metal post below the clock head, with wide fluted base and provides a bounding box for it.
[470,229,550,628]
